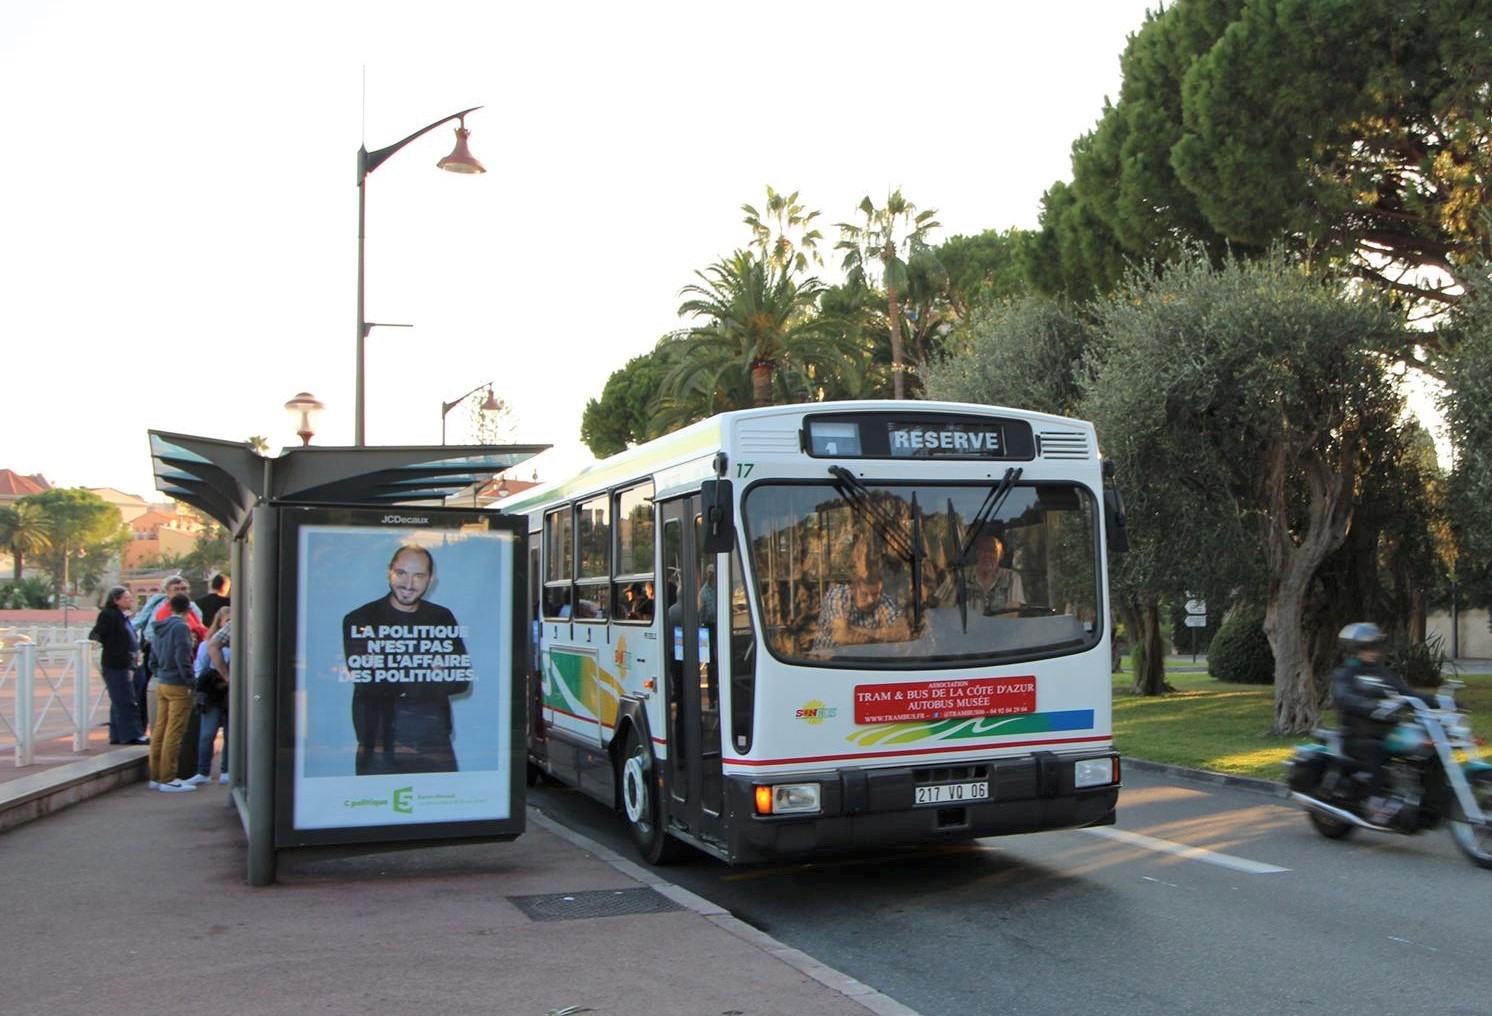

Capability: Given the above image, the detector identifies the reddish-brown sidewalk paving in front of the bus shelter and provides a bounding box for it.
[0,744,916,1016]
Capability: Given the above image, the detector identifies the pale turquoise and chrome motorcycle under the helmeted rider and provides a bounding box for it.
[1285,680,1492,868]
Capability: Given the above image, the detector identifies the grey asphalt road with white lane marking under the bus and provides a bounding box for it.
[530,770,1492,1016]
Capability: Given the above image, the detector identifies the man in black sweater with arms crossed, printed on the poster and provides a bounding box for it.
[342,545,473,776]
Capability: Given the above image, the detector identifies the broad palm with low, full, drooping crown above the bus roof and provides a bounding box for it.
[662,251,843,412]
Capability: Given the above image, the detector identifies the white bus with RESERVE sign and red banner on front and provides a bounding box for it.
[497,401,1122,864]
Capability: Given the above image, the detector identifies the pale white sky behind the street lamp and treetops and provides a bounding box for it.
[0,0,1159,498]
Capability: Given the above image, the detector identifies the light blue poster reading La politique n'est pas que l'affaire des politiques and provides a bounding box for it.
[286,516,516,831]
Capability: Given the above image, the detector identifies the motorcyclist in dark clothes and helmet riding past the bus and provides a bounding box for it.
[1331,621,1434,825]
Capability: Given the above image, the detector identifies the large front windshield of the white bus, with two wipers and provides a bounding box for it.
[742,480,1103,668]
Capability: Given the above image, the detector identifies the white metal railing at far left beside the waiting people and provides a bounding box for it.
[0,639,107,765]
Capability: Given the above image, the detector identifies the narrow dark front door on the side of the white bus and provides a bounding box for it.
[662,494,722,841]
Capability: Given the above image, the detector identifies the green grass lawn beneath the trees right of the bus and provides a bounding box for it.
[1113,659,1492,780]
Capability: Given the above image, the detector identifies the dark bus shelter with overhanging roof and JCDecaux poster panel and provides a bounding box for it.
[149,431,549,885]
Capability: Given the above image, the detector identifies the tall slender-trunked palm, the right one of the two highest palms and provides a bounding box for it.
[834,188,941,398]
